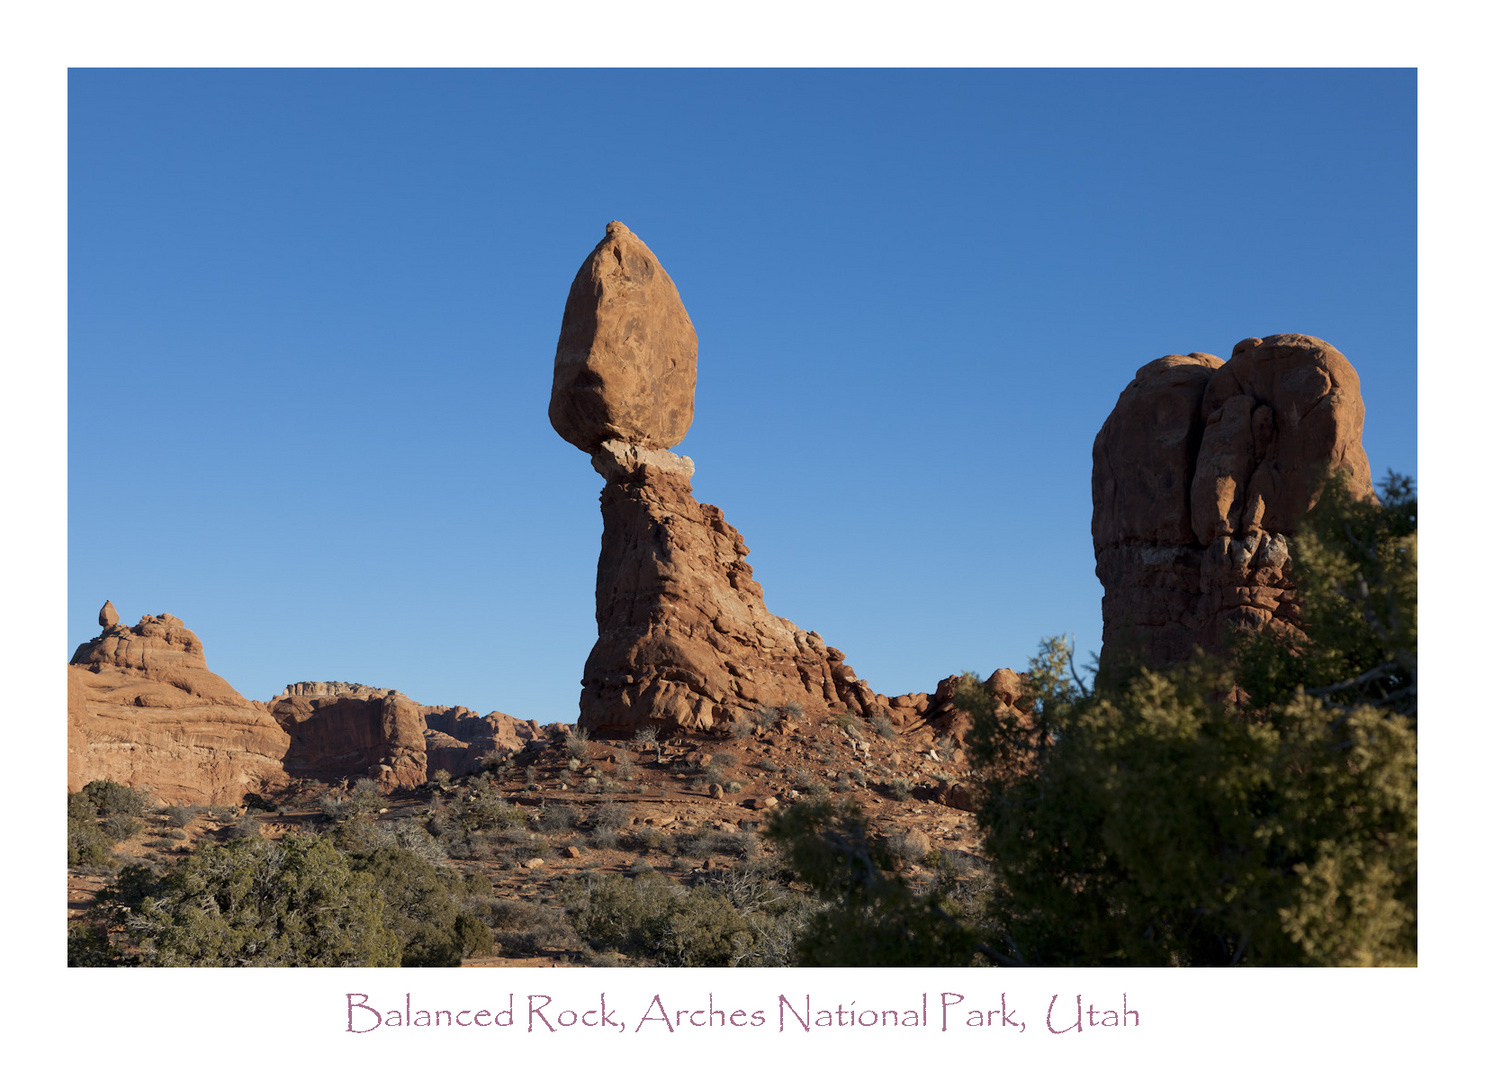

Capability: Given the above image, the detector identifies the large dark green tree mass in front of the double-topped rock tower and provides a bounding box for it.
[955,477,1417,966]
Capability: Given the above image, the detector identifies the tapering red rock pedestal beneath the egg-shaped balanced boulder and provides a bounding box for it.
[579,443,952,737]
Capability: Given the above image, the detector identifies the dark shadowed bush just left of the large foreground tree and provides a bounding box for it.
[768,801,980,967]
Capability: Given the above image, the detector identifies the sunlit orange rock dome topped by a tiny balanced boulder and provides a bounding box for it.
[67,605,290,804]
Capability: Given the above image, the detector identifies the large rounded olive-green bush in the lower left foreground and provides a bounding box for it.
[89,836,401,967]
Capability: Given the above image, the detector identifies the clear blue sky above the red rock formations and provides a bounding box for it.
[67,70,1418,722]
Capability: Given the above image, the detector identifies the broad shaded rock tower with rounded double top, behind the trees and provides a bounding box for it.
[1093,334,1372,677]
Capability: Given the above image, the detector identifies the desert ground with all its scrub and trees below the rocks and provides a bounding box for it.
[67,477,1417,966]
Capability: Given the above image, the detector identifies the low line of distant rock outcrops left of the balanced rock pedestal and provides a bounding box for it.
[67,605,541,804]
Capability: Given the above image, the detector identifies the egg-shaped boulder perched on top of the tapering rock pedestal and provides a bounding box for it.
[548,221,696,453]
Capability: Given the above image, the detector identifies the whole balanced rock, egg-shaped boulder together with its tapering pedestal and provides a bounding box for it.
[548,221,952,735]
